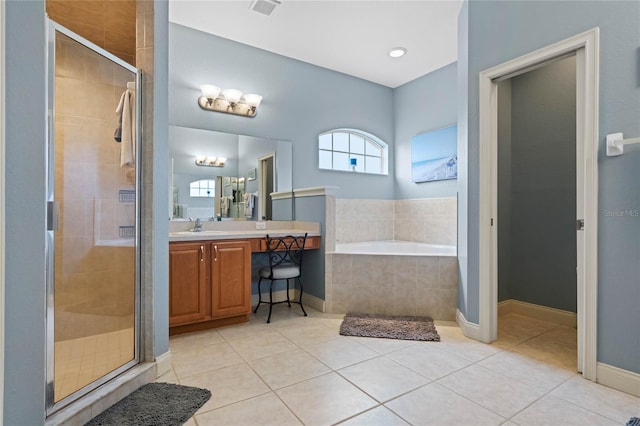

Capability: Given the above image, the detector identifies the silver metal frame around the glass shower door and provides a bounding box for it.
[45,19,142,416]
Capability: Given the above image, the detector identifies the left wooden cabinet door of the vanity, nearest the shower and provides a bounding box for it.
[169,243,211,326]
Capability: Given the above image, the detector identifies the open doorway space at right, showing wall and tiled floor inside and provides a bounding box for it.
[495,54,577,371]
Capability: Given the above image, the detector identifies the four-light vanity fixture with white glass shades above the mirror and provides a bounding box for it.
[198,84,262,117]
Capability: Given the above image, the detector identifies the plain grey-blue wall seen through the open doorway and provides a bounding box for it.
[498,56,577,312]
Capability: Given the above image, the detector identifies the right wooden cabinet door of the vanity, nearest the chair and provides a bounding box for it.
[210,241,251,318]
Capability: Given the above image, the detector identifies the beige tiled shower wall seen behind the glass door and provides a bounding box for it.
[55,35,135,322]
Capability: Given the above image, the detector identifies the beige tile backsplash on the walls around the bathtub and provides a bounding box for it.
[335,197,457,245]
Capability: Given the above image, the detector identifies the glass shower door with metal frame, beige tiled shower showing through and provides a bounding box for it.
[46,21,140,414]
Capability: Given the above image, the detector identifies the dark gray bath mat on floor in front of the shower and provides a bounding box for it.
[85,383,211,426]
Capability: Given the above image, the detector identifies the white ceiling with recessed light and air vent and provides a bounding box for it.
[169,0,462,88]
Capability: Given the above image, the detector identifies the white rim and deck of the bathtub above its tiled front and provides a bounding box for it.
[335,240,456,256]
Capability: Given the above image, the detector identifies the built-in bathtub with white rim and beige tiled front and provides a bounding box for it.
[325,241,458,321]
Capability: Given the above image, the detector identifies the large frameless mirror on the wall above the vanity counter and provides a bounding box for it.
[169,126,293,220]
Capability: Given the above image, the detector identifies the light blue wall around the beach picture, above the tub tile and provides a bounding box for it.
[393,63,457,200]
